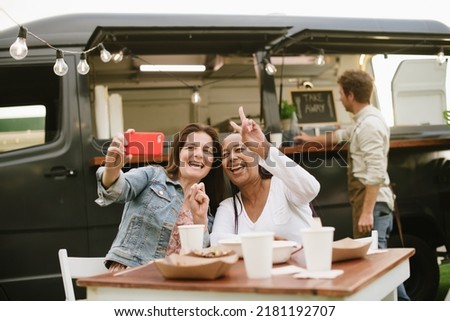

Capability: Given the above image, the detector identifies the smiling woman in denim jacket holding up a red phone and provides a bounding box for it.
[96,124,224,271]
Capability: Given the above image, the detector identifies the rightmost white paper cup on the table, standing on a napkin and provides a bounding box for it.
[301,226,334,272]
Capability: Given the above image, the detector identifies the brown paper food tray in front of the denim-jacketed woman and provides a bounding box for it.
[155,253,239,280]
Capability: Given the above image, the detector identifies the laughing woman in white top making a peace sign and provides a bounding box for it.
[211,107,320,245]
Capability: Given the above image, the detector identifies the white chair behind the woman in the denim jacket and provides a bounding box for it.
[58,249,108,301]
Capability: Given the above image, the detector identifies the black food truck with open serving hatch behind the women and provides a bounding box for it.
[0,14,450,300]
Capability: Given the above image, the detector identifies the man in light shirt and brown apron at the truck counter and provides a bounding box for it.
[294,70,409,300]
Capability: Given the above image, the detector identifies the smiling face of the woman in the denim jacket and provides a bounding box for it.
[180,132,214,181]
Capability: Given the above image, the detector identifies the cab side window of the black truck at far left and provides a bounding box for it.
[0,64,61,154]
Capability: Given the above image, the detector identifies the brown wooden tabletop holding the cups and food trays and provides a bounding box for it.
[77,248,415,299]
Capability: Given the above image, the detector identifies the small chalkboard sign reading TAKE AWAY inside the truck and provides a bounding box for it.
[291,89,337,124]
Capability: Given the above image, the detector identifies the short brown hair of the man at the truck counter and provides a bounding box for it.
[337,70,373,104]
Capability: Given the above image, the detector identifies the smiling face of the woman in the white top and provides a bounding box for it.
[222,134,259,186]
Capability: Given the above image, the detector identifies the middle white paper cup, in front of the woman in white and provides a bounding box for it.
[239,232,275,279]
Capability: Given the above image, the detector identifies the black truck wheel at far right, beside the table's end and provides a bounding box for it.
[389,234,440,301]
